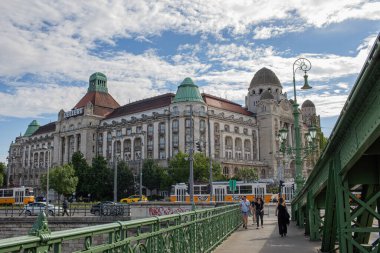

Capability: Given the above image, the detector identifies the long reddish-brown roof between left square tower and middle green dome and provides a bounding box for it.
[106,93,175,119]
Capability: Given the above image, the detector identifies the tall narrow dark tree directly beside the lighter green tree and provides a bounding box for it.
[71,151,91,198]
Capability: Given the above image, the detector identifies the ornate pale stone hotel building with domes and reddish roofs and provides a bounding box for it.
[7,68,320,191]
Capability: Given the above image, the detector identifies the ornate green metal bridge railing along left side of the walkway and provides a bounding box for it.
[0,205,241,253]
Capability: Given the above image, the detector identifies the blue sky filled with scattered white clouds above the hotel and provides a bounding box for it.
[0,0,380,162]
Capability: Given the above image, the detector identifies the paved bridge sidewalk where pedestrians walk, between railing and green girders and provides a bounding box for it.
[214,217,321,253]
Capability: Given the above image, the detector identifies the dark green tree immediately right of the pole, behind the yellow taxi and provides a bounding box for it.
[116,161,134,200]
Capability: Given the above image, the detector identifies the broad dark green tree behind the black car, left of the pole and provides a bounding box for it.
[85,156,113,200]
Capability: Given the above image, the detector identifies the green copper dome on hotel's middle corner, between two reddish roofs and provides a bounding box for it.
[173,77,204,103]
